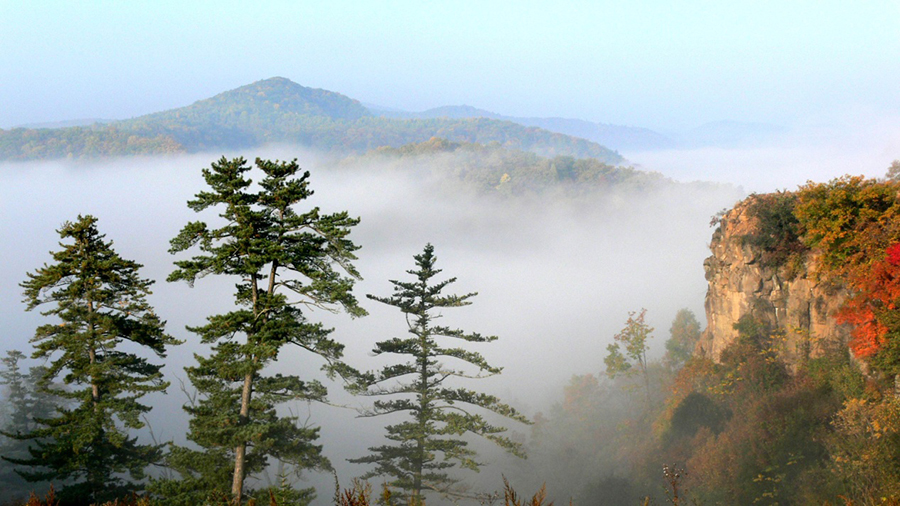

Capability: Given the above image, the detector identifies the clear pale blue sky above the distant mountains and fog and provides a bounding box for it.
[0,0,900,130]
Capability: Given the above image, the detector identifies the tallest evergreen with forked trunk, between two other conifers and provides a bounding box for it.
[154,157,365,504]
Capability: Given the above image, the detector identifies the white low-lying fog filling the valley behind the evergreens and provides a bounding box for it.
[0,137,886,498]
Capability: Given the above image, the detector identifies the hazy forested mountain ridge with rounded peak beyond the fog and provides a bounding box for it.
[0,78,623,164]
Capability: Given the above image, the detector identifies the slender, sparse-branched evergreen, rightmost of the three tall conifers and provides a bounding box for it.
[351,244,530,504]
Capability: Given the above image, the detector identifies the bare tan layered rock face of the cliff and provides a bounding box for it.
[697,197,850,369]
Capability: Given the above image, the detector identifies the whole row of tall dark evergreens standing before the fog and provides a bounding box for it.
[0,158,530,506]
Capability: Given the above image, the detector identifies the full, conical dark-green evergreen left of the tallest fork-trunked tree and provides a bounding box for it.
[8,216,175,504]
